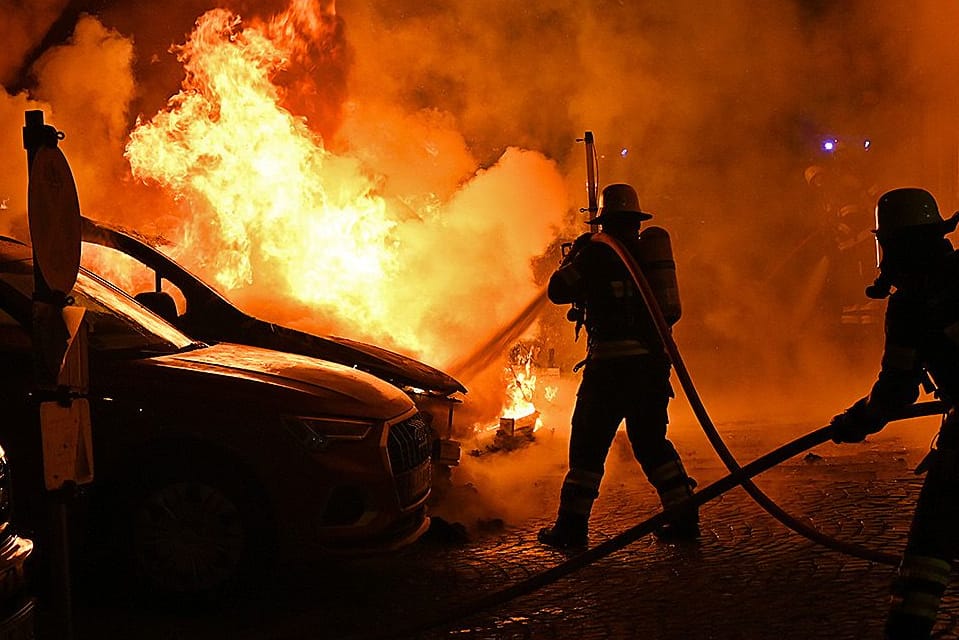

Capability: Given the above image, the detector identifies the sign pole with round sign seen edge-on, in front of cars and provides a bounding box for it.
[23,111,93,640]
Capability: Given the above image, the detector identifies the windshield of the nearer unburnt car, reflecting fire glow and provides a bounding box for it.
[0,270,196,353]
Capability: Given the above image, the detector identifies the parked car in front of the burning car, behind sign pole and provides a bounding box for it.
[0,238,431,594]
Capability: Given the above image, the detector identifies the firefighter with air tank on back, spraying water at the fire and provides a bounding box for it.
[539,184,699,549]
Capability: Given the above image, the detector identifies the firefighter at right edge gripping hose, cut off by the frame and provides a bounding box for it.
[831,188,959,640]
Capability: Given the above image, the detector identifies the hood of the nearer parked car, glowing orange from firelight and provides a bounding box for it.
[147,343,413,420]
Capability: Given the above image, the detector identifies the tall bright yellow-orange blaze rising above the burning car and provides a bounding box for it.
[126,0,397,340]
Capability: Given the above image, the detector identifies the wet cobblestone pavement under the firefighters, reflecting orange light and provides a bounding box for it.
[65,418,959,640]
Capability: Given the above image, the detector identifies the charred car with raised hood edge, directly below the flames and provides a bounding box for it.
[82,218,466,471]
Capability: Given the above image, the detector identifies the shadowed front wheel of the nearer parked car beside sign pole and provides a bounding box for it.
[111,448,273,604]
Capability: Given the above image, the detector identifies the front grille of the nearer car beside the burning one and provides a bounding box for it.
[386,414,432,507]
